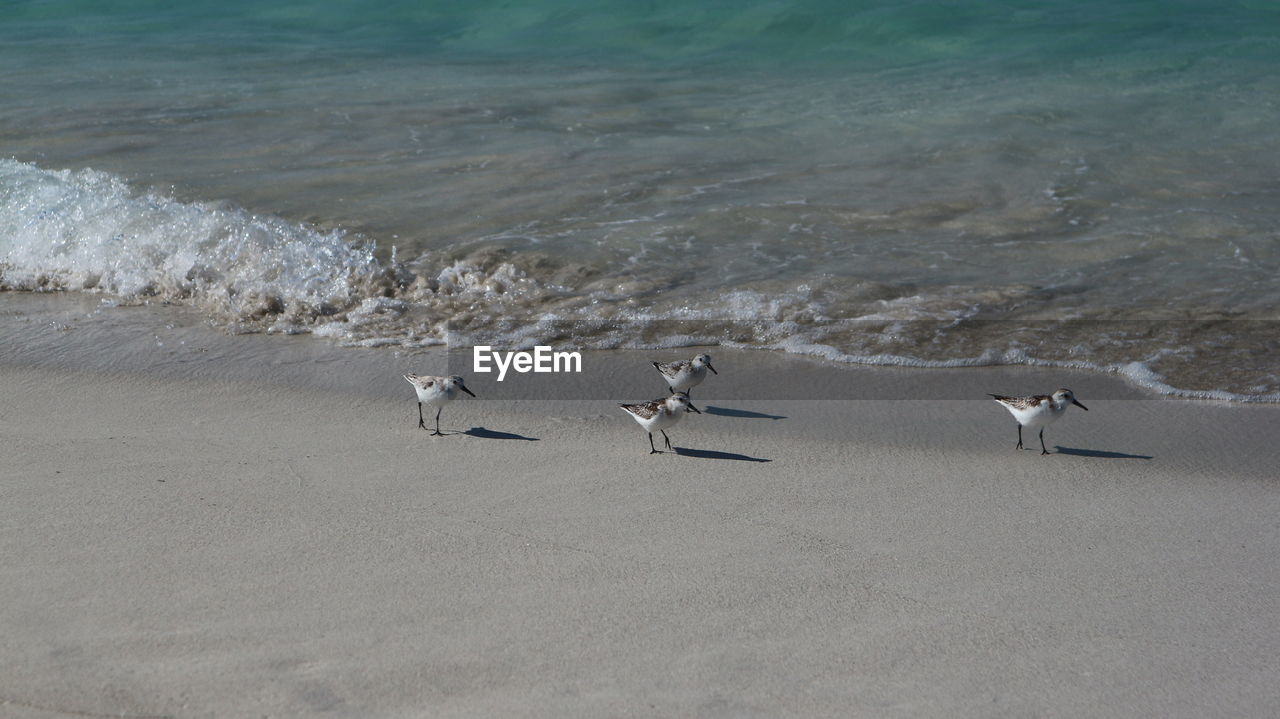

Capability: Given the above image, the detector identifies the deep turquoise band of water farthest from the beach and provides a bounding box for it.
[4,0,1280,65]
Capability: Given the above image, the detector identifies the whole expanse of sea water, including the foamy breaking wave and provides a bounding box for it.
[0,0,1280,402]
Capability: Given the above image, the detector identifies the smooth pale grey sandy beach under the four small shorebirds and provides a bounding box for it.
[0,327,1280,719]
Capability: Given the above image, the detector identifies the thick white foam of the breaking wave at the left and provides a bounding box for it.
[0,160,384,319]
